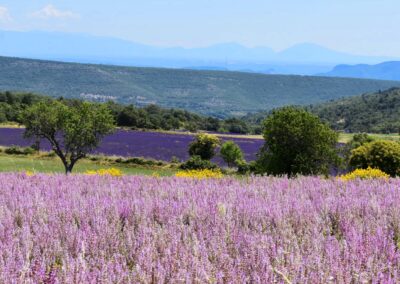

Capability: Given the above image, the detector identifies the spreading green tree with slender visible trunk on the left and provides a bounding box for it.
[22,101,115,174]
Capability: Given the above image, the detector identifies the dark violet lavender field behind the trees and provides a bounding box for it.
[0,128,263,161]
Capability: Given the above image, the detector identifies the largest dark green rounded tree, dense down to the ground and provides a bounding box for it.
[257,107,339,176]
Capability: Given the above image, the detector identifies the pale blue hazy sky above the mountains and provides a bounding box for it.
[0,0,400,56]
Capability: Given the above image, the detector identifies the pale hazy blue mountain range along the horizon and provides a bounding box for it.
[0,31,395,75]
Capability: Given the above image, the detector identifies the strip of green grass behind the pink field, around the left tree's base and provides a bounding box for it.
[0,155,175,176]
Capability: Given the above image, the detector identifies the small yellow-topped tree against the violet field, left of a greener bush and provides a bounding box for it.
[189,133,220,160]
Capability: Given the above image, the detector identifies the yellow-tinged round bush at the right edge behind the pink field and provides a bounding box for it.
[350,140,400,177]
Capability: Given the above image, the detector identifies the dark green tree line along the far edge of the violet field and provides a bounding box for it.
[0,92,250,133]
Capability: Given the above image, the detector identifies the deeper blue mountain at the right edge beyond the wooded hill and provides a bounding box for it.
[321,61,400,81]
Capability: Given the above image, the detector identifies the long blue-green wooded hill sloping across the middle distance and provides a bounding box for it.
[0,57,400,117]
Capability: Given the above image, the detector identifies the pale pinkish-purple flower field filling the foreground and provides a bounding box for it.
[0,174,400,283]
